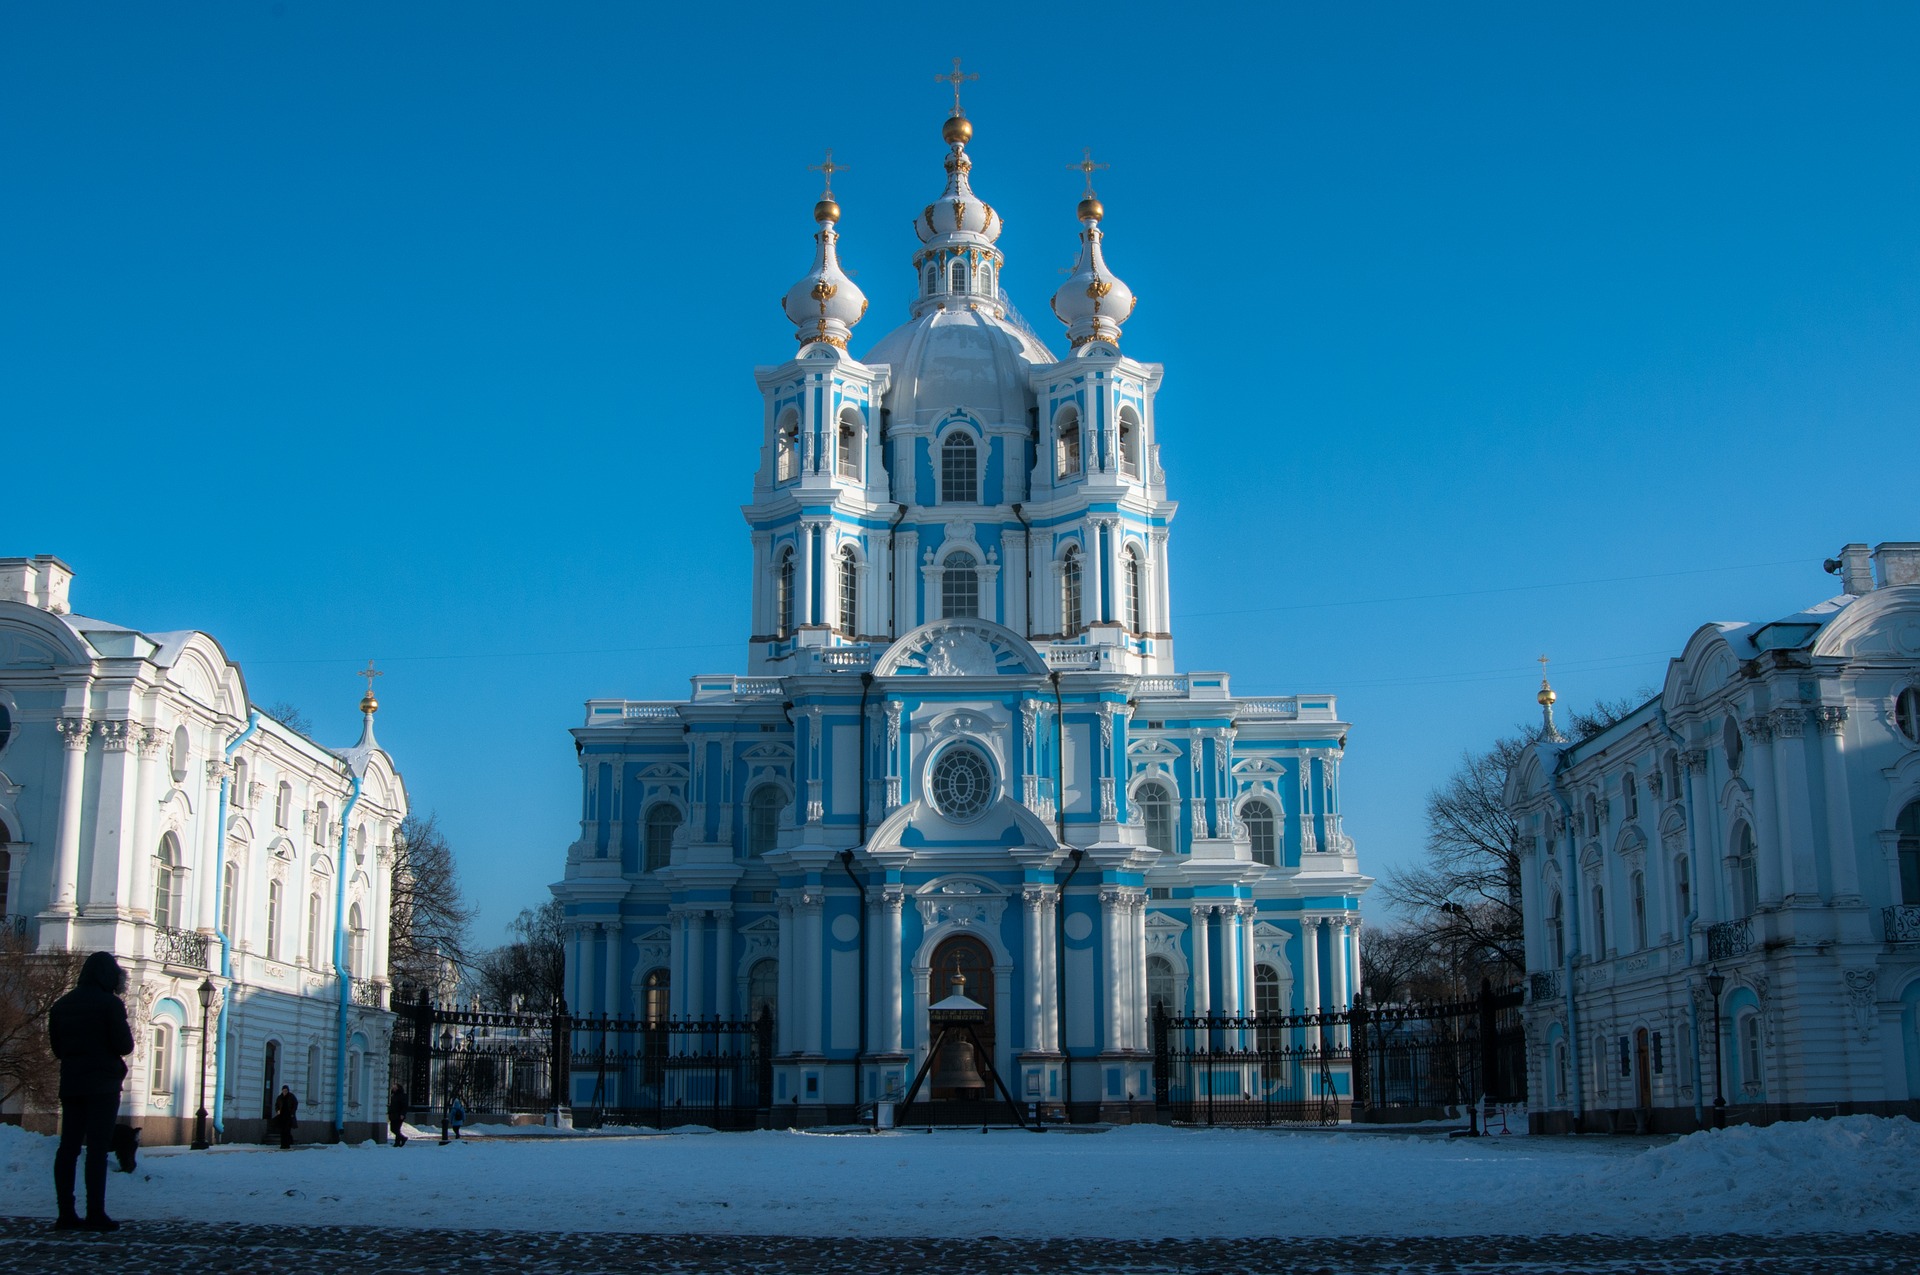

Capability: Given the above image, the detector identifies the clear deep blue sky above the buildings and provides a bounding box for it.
[0,0,1920,939]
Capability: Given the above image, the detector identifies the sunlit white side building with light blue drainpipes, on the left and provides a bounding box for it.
[0,555,407,1144]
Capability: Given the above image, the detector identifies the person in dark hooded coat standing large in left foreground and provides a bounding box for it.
[46,952,132,1231]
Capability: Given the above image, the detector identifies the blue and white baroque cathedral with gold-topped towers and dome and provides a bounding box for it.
[553,106,1371,1123]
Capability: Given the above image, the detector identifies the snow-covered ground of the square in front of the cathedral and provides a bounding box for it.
[0,1116,1920,1239]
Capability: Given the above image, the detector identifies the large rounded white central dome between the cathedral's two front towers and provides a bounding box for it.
[862,309,1058,424]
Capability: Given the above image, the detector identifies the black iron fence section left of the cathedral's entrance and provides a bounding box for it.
[392,995,774,1129]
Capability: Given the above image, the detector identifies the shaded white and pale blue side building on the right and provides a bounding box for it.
[1505,543,1920,1131]
